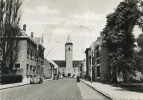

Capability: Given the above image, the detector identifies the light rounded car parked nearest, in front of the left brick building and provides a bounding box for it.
[30,74,43,84]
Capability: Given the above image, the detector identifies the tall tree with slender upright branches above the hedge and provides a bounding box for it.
[0,0,22,73]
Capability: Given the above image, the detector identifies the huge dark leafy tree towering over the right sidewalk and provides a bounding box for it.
[102,0,143,82]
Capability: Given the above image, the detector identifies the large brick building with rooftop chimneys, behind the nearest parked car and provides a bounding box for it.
[16,26,45,81]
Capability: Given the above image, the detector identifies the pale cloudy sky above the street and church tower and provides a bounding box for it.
[20,0,141,60]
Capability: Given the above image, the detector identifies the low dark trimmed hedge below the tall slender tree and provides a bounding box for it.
[0,74,23,84]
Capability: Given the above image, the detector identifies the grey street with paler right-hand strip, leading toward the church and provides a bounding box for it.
[2,78,107,100]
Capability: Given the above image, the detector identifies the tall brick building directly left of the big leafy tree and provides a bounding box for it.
[93,37,111,81]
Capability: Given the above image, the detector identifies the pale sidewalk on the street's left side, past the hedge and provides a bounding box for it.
[0,79,52,90]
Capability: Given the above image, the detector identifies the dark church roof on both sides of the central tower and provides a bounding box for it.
[54,60,82,67]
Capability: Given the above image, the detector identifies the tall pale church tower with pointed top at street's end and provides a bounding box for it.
[65,36,73,76]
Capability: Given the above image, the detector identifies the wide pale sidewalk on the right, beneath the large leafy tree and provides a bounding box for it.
[81,79,143,100]
